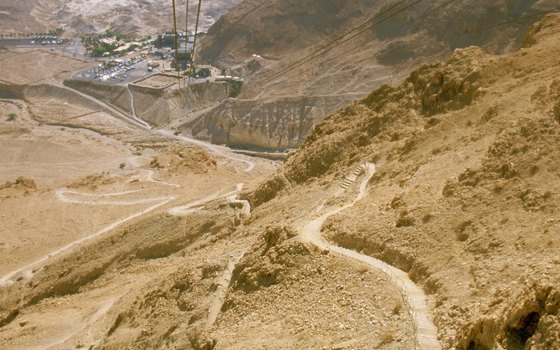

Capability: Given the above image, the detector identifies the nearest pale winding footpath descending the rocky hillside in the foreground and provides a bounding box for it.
[299,163,441,350]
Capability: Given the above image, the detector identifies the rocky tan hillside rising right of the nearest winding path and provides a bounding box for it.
[247,14,560,350]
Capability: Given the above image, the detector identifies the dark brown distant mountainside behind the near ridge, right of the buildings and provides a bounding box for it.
[200,0,557,91]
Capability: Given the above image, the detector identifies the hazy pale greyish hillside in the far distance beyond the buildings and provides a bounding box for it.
[0,0,239,36]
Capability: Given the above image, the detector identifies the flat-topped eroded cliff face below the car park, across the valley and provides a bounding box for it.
[184,95,355,150]
